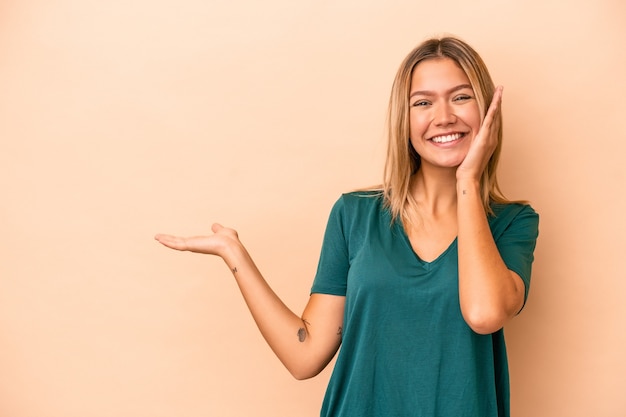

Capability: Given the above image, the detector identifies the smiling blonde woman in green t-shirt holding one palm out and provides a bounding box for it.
[156,37,538,417]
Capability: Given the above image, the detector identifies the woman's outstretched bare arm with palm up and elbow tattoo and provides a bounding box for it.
[155,224,345,379]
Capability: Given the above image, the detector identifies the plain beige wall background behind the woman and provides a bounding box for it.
[0,0,626,417]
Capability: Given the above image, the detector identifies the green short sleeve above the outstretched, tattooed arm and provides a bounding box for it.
[311,196,350,296]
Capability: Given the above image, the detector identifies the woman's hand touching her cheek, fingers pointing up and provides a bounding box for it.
[456,86,502,181]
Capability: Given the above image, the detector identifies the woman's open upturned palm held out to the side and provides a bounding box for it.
[154,223,241,258]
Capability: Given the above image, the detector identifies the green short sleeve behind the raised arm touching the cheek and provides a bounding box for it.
[492,204,539,303]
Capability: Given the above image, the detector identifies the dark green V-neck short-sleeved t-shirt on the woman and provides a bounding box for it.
[311,192,539,417]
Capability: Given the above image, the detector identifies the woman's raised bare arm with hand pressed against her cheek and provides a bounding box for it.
[457,87,525,334]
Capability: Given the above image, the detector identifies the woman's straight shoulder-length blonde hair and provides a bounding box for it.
[382,36,510,222]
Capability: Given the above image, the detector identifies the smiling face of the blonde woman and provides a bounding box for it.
[409,58,480,169]
